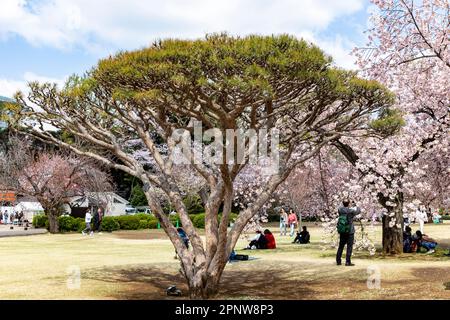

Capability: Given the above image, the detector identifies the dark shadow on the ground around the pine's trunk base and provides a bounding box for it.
[83,262,320,300]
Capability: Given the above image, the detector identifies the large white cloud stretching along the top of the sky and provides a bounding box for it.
[0,0,364,51]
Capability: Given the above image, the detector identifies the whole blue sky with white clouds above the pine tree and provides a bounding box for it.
[0,0,371,96]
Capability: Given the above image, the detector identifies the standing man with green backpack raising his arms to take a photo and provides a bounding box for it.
[336,199,361,266]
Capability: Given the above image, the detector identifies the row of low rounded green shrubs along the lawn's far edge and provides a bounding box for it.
[33,213,237,232]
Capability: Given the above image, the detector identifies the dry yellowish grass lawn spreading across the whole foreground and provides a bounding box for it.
[0,221,450,299]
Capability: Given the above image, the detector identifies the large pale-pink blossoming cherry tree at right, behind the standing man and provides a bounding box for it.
[334,0,450,253]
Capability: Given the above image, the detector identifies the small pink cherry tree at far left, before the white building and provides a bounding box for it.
[0,137,112,233]
